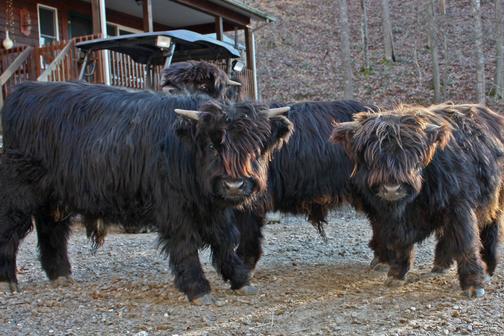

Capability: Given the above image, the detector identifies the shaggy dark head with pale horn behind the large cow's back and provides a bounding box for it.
[161,61,241,99]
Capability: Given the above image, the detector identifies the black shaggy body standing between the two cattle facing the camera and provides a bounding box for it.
[235,101,370,269]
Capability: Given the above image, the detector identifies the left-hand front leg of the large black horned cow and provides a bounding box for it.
[161,233,213,304]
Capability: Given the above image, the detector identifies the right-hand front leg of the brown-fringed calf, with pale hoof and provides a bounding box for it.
[444,208,485,297]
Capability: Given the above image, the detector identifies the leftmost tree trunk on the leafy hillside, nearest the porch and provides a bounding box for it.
[339,0,353,99]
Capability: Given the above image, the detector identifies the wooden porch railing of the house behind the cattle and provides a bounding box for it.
[0,34,254,103]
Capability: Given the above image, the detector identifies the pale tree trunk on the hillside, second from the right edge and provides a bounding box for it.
[471,0,486,104]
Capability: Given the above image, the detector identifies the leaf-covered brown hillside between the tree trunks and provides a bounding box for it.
[243,0,504,112]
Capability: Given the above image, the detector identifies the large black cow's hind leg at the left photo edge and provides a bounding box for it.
[0,213,32,292]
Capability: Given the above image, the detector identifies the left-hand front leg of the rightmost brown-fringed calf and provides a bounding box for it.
[385,244,414,286]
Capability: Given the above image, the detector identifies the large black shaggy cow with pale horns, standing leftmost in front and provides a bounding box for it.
[0,83,292,302]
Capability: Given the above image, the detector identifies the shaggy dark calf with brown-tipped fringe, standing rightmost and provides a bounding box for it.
[331,104,504,297]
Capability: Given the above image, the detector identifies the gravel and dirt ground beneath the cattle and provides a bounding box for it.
[0,209,504,336]
